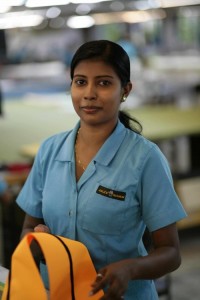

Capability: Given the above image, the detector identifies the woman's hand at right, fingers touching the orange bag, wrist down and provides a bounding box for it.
[90,260,131,300]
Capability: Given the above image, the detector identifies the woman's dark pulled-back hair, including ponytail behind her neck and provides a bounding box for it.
[70,40,142,133]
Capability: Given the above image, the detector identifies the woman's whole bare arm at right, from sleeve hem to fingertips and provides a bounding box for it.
[91,224,181,300]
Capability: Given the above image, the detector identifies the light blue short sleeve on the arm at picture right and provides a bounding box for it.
[137,144,186,231]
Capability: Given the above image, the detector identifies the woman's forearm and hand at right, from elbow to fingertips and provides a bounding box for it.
[91,246,180,299]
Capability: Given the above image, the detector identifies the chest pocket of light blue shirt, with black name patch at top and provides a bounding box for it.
[81,183,130,235]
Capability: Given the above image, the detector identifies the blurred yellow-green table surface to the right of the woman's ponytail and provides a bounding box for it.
[129,105,200,140]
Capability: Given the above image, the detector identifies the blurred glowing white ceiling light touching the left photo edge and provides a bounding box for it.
[0,12,44,29]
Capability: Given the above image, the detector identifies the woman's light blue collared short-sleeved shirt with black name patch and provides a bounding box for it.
[17,122,186,300]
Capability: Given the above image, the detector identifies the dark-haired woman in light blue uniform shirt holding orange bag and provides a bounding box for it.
[17,40,186,300]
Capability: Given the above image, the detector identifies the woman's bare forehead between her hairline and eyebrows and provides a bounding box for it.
[74,59,118,77]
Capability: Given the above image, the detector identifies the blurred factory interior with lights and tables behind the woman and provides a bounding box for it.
[0,0,200,300]
